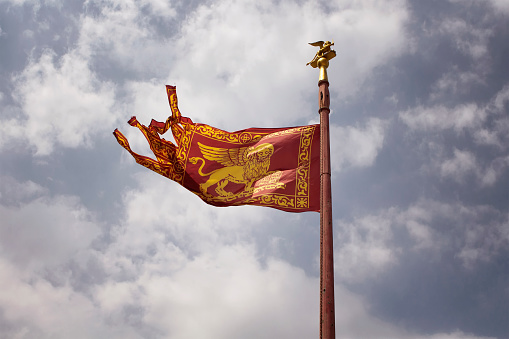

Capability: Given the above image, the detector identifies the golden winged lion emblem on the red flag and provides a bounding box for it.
[189,142,274,197]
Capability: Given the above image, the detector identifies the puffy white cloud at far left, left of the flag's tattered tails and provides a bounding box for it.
[5,51,116,155]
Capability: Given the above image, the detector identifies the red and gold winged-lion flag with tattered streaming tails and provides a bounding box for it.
[113,86,320,212]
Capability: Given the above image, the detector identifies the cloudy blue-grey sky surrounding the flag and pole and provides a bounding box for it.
[0,0,509,339]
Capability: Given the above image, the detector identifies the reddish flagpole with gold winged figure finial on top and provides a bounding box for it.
[308,41,336,339]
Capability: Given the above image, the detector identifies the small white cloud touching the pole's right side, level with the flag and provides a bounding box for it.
[330,118,387,171]
